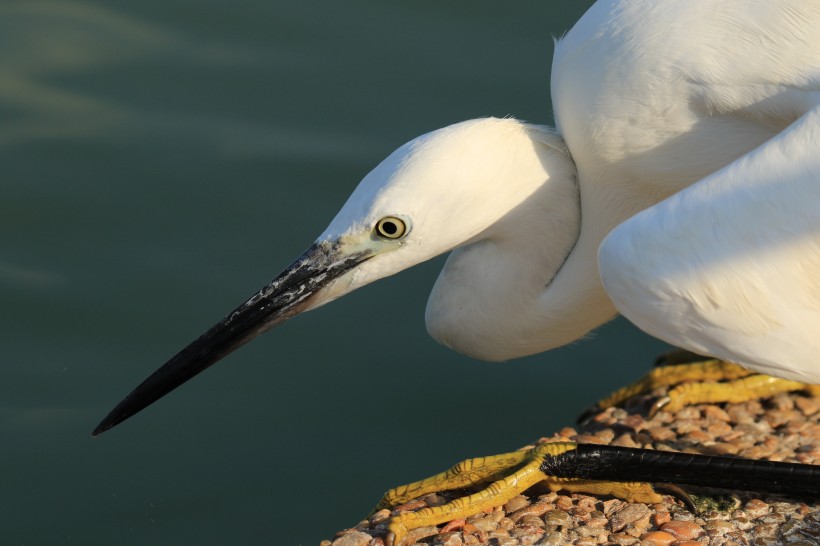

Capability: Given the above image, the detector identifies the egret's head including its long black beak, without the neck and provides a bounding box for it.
[94,118,571,434]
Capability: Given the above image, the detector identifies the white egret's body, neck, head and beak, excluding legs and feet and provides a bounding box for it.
[95,0,820,540]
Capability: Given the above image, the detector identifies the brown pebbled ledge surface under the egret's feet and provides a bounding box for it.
[320,384,820,546]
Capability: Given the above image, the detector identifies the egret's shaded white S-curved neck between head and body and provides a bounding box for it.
[426,126,615,360]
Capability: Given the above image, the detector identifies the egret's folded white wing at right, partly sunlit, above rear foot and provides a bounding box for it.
[599,107,820,378]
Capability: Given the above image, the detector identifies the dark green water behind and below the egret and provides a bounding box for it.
[0,0,664,546]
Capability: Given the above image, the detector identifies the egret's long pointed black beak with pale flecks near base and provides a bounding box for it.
[92,243,373,436]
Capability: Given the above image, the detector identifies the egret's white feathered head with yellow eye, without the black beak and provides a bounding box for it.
[307,118,566,309]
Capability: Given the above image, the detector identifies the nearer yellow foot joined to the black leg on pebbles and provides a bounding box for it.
[376,443,662,546]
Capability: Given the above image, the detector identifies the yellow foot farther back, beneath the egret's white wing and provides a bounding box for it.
[596,350,820,415]
